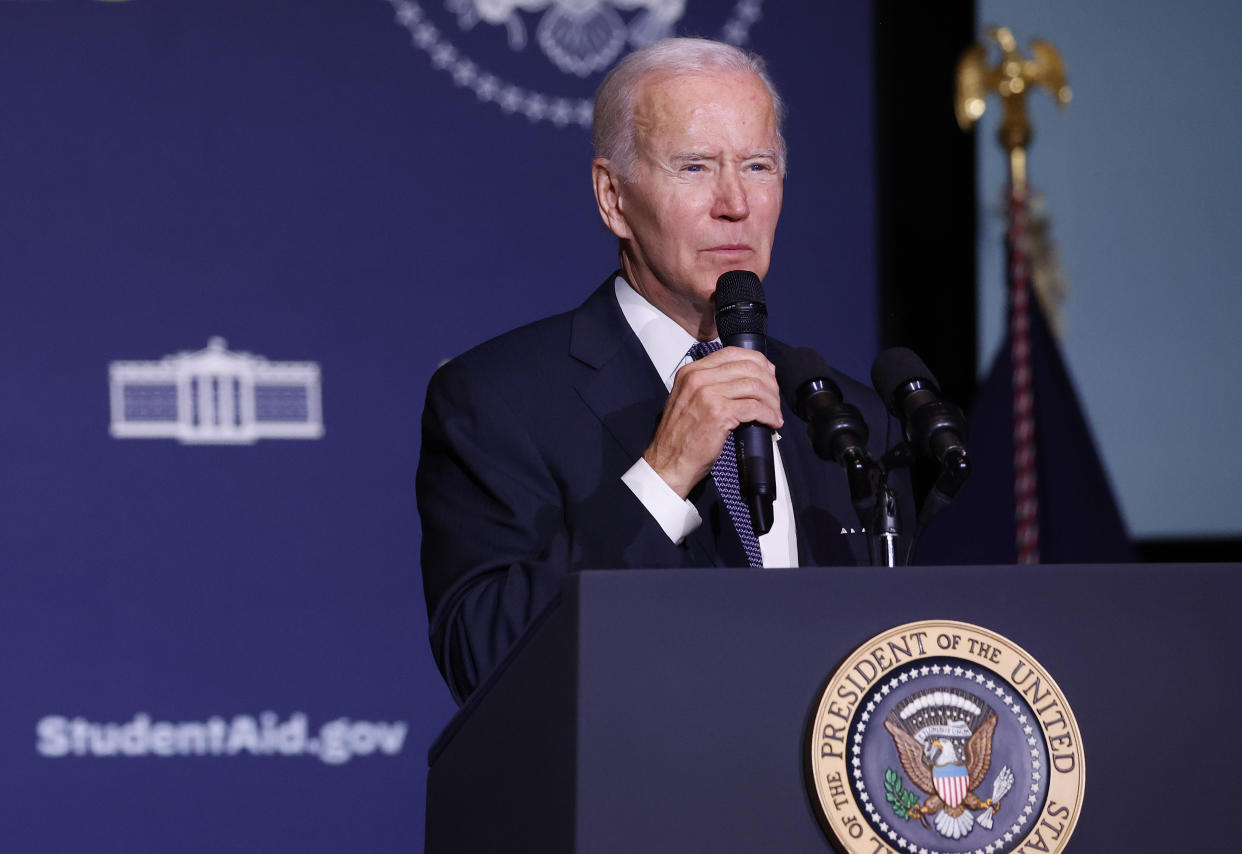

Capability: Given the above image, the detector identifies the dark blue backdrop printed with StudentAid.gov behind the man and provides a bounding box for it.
[0,0,877,852]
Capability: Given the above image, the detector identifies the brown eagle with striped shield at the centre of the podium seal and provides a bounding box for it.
[884,690,1000,839]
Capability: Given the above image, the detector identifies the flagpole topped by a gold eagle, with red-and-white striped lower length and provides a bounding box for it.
[954,27,1071,564]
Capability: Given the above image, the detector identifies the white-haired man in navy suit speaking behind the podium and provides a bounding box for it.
[417,38,904,701]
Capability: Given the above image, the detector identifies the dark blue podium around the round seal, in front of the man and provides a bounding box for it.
[426,564,1242,854]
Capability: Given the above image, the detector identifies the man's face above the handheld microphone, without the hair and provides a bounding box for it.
[610,72,784,334]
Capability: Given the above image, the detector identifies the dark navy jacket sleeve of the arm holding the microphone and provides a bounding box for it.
[417,337,686,703]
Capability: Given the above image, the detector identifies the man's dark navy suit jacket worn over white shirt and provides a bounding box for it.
[417,276,912,701]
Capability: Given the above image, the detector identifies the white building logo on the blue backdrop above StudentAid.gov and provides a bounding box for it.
[108,338,323,444]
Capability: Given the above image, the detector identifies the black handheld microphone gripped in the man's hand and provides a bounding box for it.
[715,269,776,536]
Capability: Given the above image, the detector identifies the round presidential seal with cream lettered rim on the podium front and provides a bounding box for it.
[807,621,1084,854]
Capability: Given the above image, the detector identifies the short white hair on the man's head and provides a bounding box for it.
[591,38,785,181]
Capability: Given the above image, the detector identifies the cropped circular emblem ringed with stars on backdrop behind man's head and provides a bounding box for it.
[388,0,763,128]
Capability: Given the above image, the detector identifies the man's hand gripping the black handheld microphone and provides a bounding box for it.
[642,346,784,499]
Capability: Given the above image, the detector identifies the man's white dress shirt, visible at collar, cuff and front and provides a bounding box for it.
[614,276,797,566]
